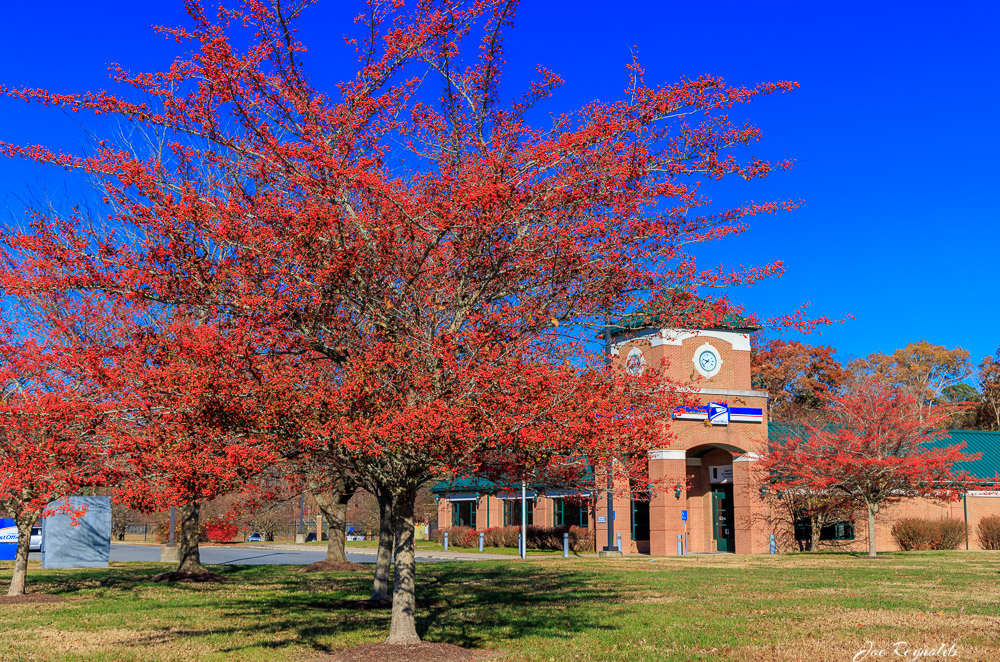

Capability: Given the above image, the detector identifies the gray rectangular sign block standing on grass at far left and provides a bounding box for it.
[42,497,111,568]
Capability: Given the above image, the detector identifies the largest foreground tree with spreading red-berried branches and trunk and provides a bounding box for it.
[0,0,824,643]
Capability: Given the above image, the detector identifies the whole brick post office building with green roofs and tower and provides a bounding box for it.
[433,306,1000,556]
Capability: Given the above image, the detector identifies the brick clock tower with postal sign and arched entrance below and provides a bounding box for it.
[598,293,768,556]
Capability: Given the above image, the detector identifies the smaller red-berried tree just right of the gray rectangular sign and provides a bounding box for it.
[113,316,279,577]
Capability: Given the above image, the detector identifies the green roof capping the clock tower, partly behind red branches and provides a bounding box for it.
[611,290,759,336]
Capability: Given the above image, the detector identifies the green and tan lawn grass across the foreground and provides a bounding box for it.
[0,552,1000,661]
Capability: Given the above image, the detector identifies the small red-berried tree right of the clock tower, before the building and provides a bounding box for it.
[759,379,981,557]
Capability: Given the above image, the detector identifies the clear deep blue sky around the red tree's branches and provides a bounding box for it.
[0,0,1000,362]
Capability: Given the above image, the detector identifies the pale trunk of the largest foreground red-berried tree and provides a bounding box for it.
[385,487,420,644]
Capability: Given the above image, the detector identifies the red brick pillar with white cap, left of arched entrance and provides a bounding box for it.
[649,449,687,556]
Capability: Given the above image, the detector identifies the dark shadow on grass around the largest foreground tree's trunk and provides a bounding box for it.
[210,562,612,652]
